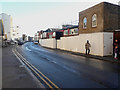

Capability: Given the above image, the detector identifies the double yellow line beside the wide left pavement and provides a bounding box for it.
[12,48,60,90]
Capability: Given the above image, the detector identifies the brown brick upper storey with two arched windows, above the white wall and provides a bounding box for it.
[79,2,120,34]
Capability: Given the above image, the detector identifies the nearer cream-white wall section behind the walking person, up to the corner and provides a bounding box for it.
[57,32,103,56]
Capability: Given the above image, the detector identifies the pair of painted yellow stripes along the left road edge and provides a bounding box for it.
[14,49,60,90]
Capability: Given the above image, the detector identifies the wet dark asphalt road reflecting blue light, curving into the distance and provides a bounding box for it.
[17,42,120,88]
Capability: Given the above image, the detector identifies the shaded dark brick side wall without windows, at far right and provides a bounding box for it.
[104,3,120,31]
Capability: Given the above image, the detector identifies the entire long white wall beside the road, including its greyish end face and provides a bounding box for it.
[40,32,113,56]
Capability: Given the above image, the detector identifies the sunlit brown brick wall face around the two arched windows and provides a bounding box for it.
[79,3,104,34]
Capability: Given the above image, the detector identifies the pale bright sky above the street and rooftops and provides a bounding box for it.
[0,0,119,36]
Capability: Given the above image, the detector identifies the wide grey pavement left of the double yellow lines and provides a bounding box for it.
[2,46,44,88]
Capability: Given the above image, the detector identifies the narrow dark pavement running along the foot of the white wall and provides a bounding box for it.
[42,46,120,64]
